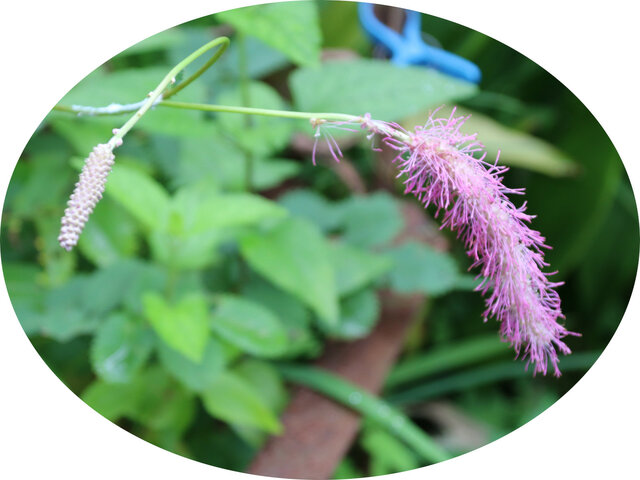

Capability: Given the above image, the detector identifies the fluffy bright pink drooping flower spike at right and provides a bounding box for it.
[314,109,576,376]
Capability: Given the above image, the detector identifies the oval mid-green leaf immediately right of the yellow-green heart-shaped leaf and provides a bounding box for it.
[211,295,287,357]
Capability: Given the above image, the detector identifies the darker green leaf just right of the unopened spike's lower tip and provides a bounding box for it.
[78,198,139,267]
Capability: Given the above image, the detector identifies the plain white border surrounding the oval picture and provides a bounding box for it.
[0,0,640,480]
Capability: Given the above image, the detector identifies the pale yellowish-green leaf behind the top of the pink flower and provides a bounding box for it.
[402,108,578,177]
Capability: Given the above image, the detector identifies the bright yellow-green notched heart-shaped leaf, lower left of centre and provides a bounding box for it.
[142,293,209,362]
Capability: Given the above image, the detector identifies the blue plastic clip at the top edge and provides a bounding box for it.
[358,3,482,83]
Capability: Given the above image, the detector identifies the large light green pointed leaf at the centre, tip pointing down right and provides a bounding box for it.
[240,219,338,324]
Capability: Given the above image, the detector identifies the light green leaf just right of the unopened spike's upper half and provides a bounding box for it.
[105,159,169,230]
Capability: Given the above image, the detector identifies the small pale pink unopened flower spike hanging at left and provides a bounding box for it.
[58,144,115,251]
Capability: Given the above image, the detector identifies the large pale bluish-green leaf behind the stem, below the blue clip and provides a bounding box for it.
[289,59,476,122]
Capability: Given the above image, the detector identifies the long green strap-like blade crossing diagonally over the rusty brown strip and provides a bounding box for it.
[277,365,451,463]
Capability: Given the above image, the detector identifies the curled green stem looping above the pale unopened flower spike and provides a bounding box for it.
[108,37,229,148]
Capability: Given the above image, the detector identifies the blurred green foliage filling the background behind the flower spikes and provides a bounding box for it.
[0,1,638,478]
